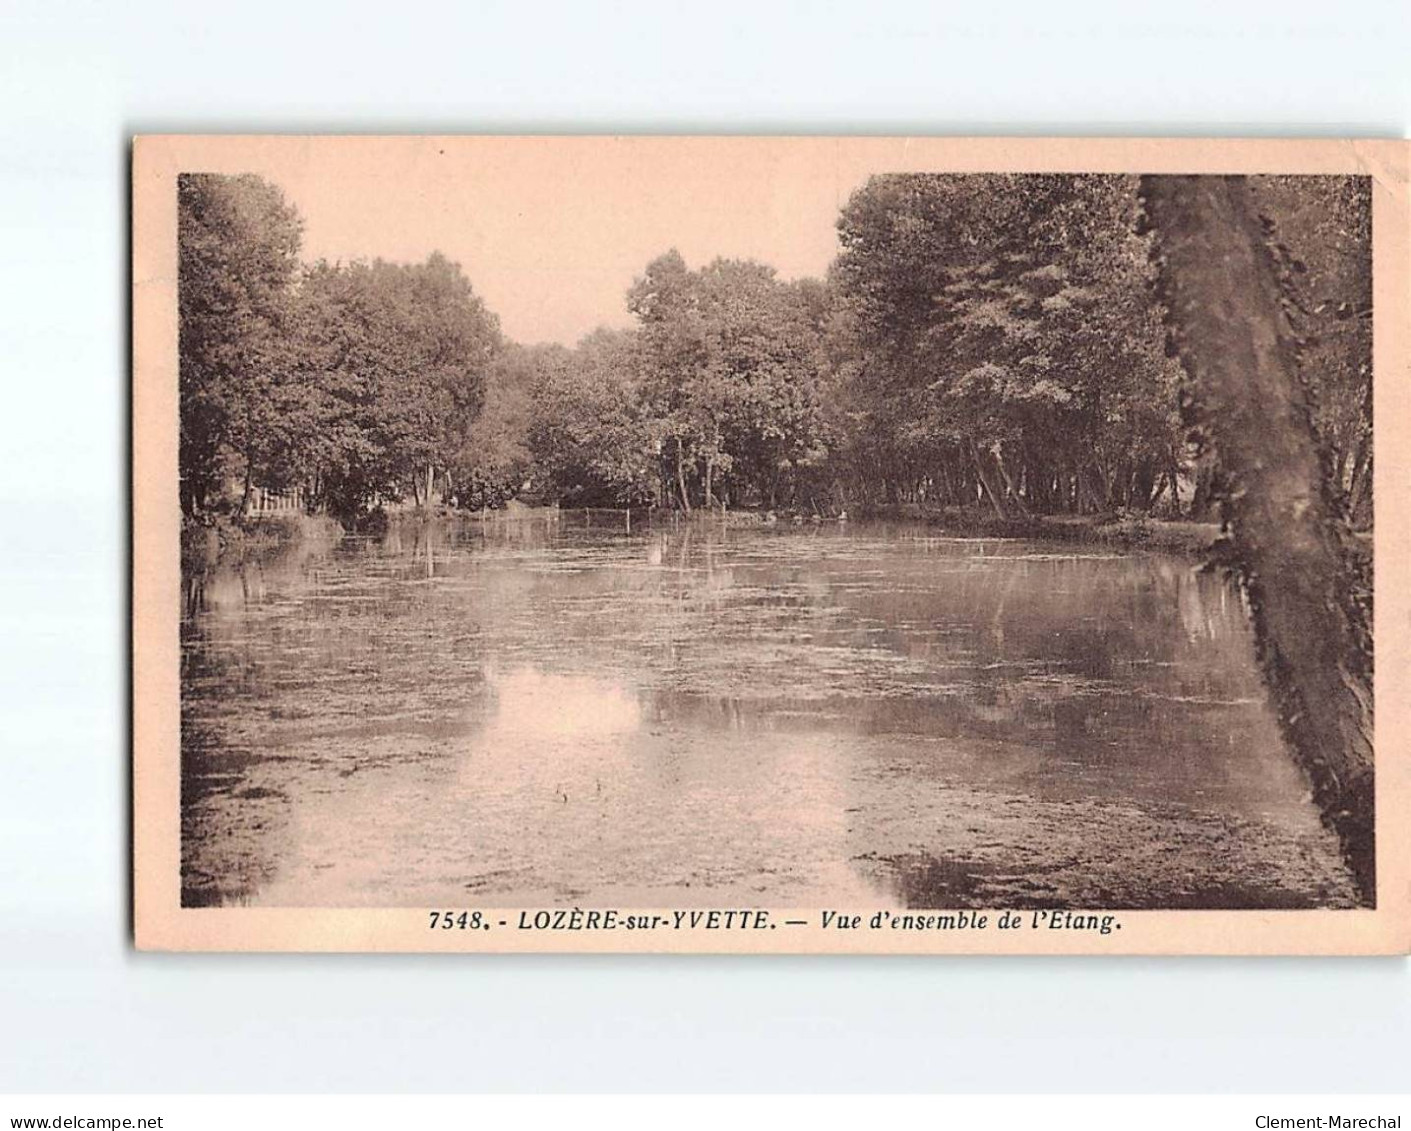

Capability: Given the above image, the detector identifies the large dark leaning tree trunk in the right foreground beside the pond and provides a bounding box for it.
[1141,176,1376,904]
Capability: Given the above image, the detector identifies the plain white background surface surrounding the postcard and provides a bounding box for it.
[0,0,1411,1092]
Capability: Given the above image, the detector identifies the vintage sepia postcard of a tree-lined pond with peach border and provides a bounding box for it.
[133,137,1411,955]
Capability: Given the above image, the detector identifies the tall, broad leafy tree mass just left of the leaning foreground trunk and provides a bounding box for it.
[831,175,1180,518]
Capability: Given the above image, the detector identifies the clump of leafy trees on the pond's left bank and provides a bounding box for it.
[178,175,501,520]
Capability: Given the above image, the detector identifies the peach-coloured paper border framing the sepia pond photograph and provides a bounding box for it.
[131,135,1411,955]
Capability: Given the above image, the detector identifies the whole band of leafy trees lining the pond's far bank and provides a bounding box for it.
[181,173,1371,533]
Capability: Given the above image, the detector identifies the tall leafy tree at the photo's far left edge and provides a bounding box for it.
[176,173,301,515]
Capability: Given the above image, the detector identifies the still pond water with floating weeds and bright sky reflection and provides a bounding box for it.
[182,519,1353,908]
